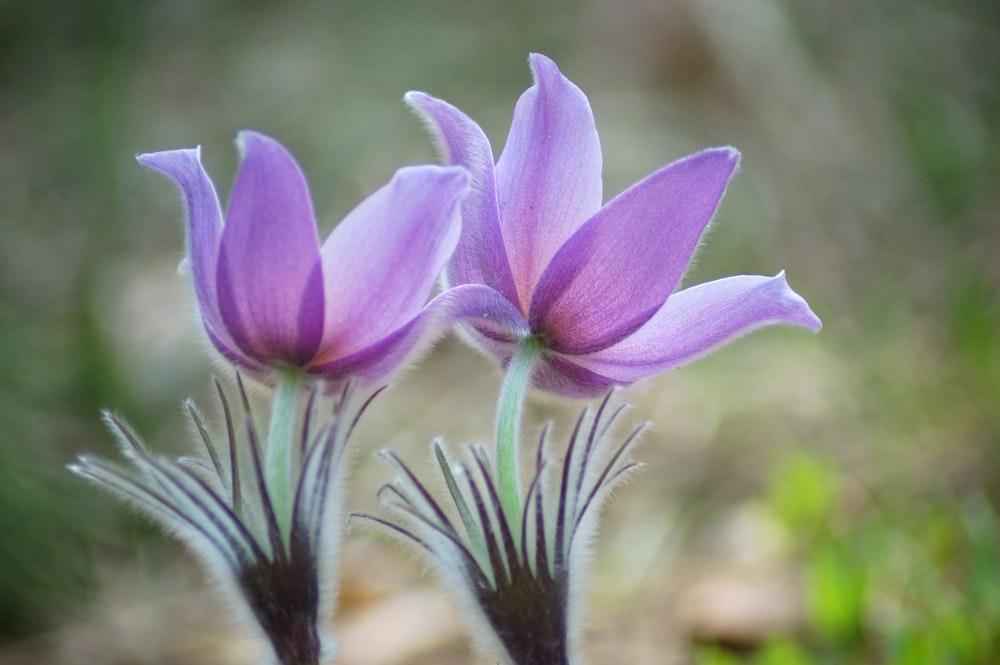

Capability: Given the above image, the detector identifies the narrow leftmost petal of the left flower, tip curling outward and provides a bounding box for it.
[136,147,235,355]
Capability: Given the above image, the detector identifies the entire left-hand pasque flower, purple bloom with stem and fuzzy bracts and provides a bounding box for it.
[112,132,528,665]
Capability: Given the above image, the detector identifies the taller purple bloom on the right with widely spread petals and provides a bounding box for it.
[407,54,821,397]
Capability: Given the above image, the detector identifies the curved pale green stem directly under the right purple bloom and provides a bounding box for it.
[496,337,541,534]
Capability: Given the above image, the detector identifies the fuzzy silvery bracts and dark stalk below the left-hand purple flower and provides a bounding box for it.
[70,375,378,665]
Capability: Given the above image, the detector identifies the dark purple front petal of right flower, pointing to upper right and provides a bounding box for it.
[528,148,739,355]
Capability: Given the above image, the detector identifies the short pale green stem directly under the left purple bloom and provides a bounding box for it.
[264,369,302,542]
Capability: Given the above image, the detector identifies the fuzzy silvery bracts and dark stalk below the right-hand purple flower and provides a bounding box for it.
[356,394,645,665]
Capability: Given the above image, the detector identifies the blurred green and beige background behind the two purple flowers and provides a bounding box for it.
[0,0,1000,665]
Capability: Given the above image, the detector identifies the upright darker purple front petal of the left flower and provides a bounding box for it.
[217,132,324,365]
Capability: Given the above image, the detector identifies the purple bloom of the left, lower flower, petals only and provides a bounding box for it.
[138,132,500,382]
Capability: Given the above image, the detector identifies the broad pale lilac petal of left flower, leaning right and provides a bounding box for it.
[315,166,469,364]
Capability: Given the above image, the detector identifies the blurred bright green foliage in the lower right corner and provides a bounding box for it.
[696,453,1000,665]
